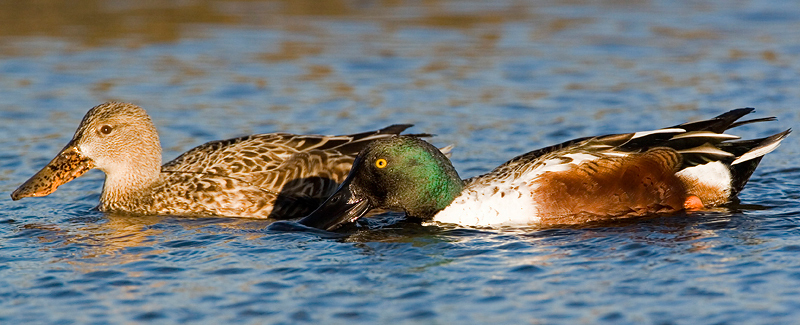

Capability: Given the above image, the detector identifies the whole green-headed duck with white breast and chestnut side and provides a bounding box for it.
[300,108,791,230]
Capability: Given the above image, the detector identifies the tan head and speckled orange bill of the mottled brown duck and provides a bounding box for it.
[11,102,161,200]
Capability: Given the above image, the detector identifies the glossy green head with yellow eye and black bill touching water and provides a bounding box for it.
[300,136,463,230]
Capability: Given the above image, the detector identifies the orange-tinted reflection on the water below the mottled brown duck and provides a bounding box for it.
[11,211,276,272]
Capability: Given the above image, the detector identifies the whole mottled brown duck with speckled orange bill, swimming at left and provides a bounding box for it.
[11,102,418,218]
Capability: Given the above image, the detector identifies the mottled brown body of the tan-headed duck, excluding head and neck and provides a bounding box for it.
[156,125,411,218]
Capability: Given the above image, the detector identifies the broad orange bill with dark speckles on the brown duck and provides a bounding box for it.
[11,146,94,200]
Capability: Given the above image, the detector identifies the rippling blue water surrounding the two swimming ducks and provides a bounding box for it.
[0,1,800,324]
